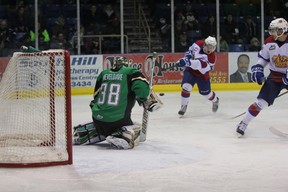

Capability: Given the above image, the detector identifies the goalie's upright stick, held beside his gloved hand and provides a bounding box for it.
[140,52,157,142]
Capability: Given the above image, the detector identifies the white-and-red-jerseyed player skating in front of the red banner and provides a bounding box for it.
[177,36,219,117]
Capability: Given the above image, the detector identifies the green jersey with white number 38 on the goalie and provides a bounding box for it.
[92,67,150,122]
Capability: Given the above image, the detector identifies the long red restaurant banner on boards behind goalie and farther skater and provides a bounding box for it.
[103,53,228,85]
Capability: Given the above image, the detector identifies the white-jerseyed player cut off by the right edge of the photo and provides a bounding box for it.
[236,18,288,137]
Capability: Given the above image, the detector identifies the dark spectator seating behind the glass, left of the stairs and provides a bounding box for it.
[0,0,120,57]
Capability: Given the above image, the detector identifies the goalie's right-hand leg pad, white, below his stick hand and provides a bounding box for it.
[106,125,142,149]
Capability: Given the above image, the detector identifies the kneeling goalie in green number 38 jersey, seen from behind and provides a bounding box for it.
[73,57,163,149]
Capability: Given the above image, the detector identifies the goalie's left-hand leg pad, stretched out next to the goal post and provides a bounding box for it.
[73,122,105,145]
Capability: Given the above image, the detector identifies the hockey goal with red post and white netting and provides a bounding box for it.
[0,50,72,167]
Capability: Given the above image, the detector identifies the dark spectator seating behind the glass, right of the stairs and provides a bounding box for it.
[148,0,288,52]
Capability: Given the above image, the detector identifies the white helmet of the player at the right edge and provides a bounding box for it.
[268,18,288,40]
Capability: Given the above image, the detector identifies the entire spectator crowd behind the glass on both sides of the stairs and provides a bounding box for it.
[0,0,288,56]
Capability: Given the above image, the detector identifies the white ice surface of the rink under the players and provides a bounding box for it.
[0,91,288,192]
